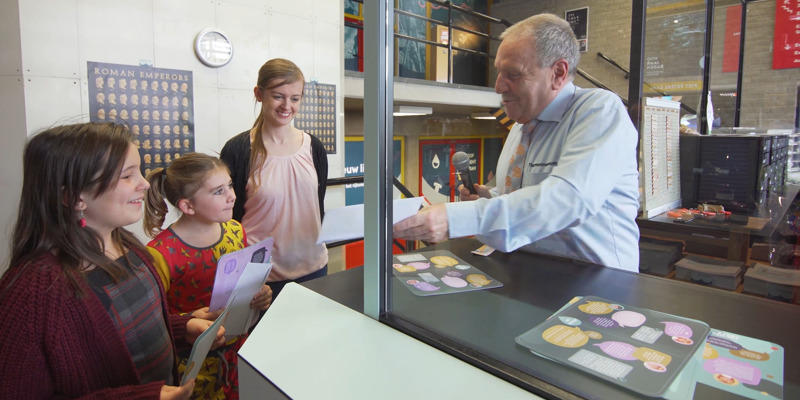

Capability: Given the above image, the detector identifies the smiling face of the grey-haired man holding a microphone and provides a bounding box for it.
[494,36,558,124]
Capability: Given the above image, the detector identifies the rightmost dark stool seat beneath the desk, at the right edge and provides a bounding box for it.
[744,262,800,304]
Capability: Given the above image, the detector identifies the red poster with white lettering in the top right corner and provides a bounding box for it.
[772,0,800,69]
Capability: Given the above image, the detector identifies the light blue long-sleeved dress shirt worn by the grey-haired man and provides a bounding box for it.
[446,82,639,272]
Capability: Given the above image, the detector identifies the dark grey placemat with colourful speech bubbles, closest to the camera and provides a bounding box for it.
[516,296,711,396]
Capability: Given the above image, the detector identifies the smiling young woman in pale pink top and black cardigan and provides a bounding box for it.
[220,58,328,297]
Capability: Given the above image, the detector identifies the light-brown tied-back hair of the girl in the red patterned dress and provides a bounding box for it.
[143,153,230,237]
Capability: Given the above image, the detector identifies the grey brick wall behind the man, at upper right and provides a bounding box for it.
[490,0,800,129]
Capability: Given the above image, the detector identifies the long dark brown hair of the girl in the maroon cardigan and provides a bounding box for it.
[8,123,144,296]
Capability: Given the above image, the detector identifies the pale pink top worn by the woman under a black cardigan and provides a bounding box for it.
[242,132,328,282]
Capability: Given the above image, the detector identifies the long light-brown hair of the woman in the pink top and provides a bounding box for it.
[250,58,305,187]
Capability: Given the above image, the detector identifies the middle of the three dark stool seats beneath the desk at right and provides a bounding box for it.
[675,254,745,290]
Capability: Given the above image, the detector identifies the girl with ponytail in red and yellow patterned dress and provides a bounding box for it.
[144,153,272,399]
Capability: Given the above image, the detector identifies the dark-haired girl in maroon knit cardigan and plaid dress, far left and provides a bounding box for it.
[0,123,224,399]
